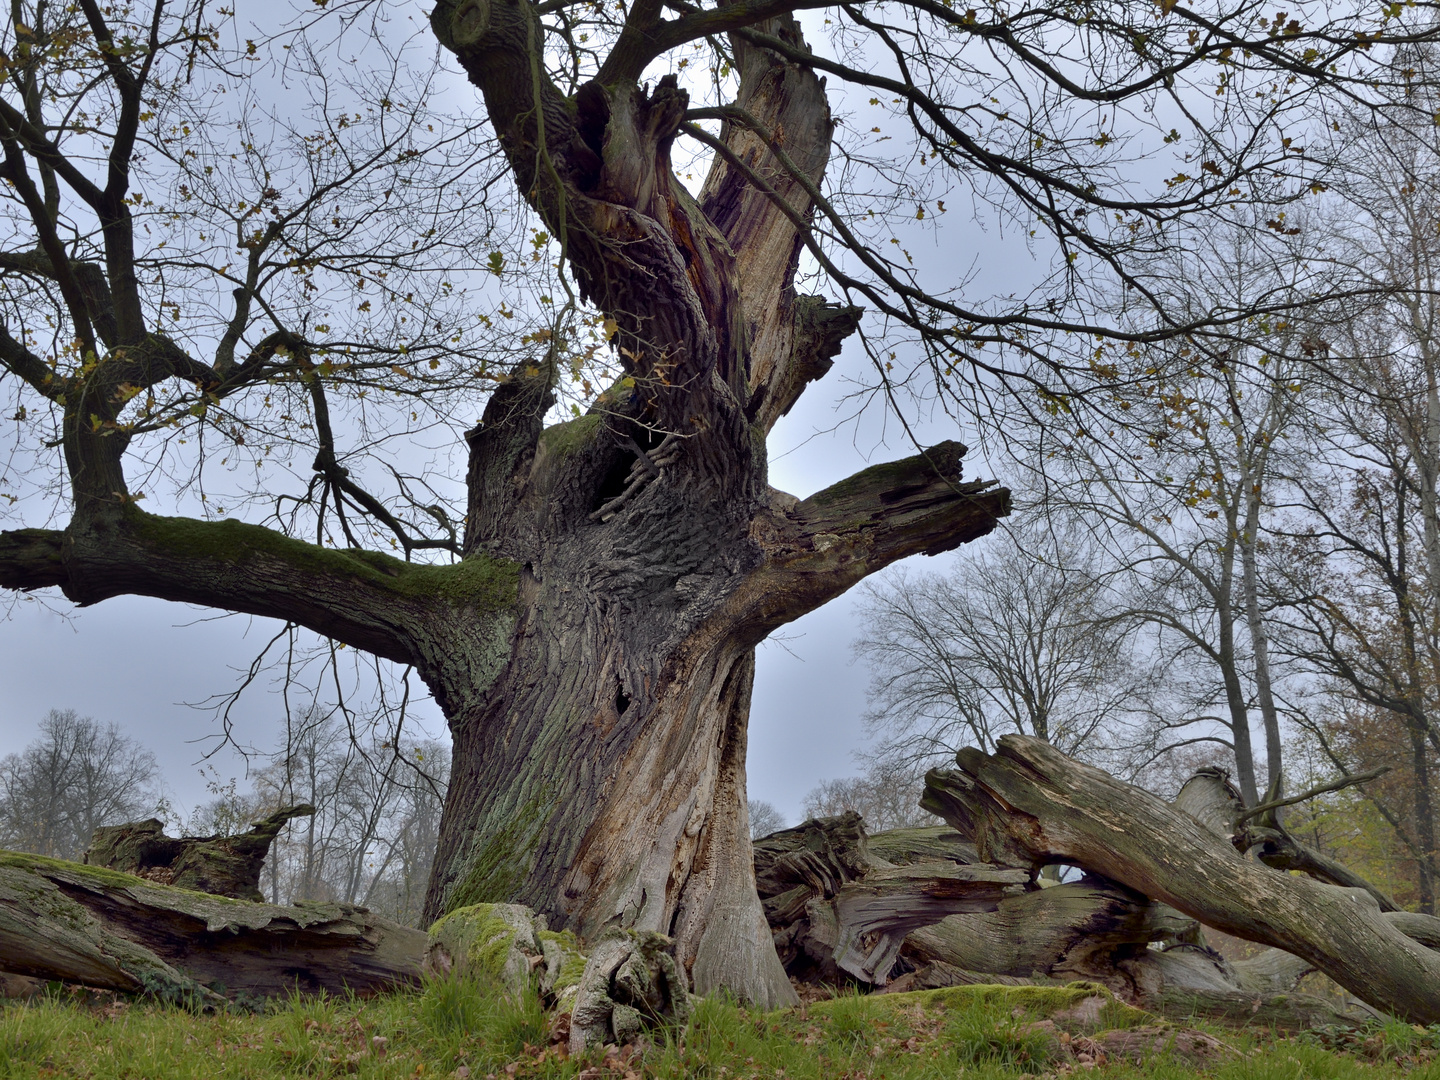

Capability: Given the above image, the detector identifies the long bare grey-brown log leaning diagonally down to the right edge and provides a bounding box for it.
[923,736,1440,1024]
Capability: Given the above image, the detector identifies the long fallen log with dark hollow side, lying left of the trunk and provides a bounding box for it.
[0,851,426,999]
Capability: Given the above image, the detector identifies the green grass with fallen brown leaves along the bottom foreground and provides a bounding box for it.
[0,981,1440,1080]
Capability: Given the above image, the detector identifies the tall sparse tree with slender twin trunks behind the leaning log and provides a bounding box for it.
[1028,292,1316,805]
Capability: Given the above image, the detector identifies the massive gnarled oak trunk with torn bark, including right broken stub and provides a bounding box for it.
[426,0,1007,1005]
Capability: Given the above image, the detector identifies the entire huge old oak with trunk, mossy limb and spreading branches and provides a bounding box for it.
[0,0,1433,1005]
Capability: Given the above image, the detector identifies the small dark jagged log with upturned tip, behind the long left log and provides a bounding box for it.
[82,804,315,903]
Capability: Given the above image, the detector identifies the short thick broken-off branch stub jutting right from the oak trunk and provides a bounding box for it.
[720,442,1009,639]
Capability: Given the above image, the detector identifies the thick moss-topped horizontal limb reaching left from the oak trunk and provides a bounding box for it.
[0,505,518,668]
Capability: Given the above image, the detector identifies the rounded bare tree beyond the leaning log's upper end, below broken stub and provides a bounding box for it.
[855,520,1149,778]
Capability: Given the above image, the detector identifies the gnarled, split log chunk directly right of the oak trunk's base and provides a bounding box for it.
[755,812,1030,986]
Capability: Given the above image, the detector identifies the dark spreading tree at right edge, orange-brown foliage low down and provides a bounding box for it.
[1282,341,1440,913]
